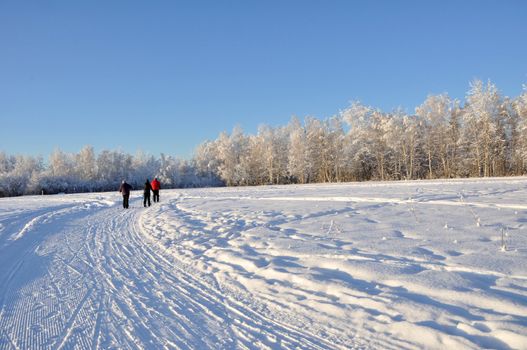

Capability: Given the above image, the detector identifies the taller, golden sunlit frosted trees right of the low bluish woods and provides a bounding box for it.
[195,80,527,185]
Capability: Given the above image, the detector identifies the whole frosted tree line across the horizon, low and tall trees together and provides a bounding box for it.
[0,80,527,196]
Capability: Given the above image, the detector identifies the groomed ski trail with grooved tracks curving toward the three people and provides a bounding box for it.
[0,198,354,350]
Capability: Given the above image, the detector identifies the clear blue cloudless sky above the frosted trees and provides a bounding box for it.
[0,0,527,157]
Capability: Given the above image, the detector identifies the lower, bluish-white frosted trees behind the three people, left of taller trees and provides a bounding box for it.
[0,146,223,197]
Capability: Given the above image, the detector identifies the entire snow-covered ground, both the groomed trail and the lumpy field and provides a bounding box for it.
[0,178,527,349]
